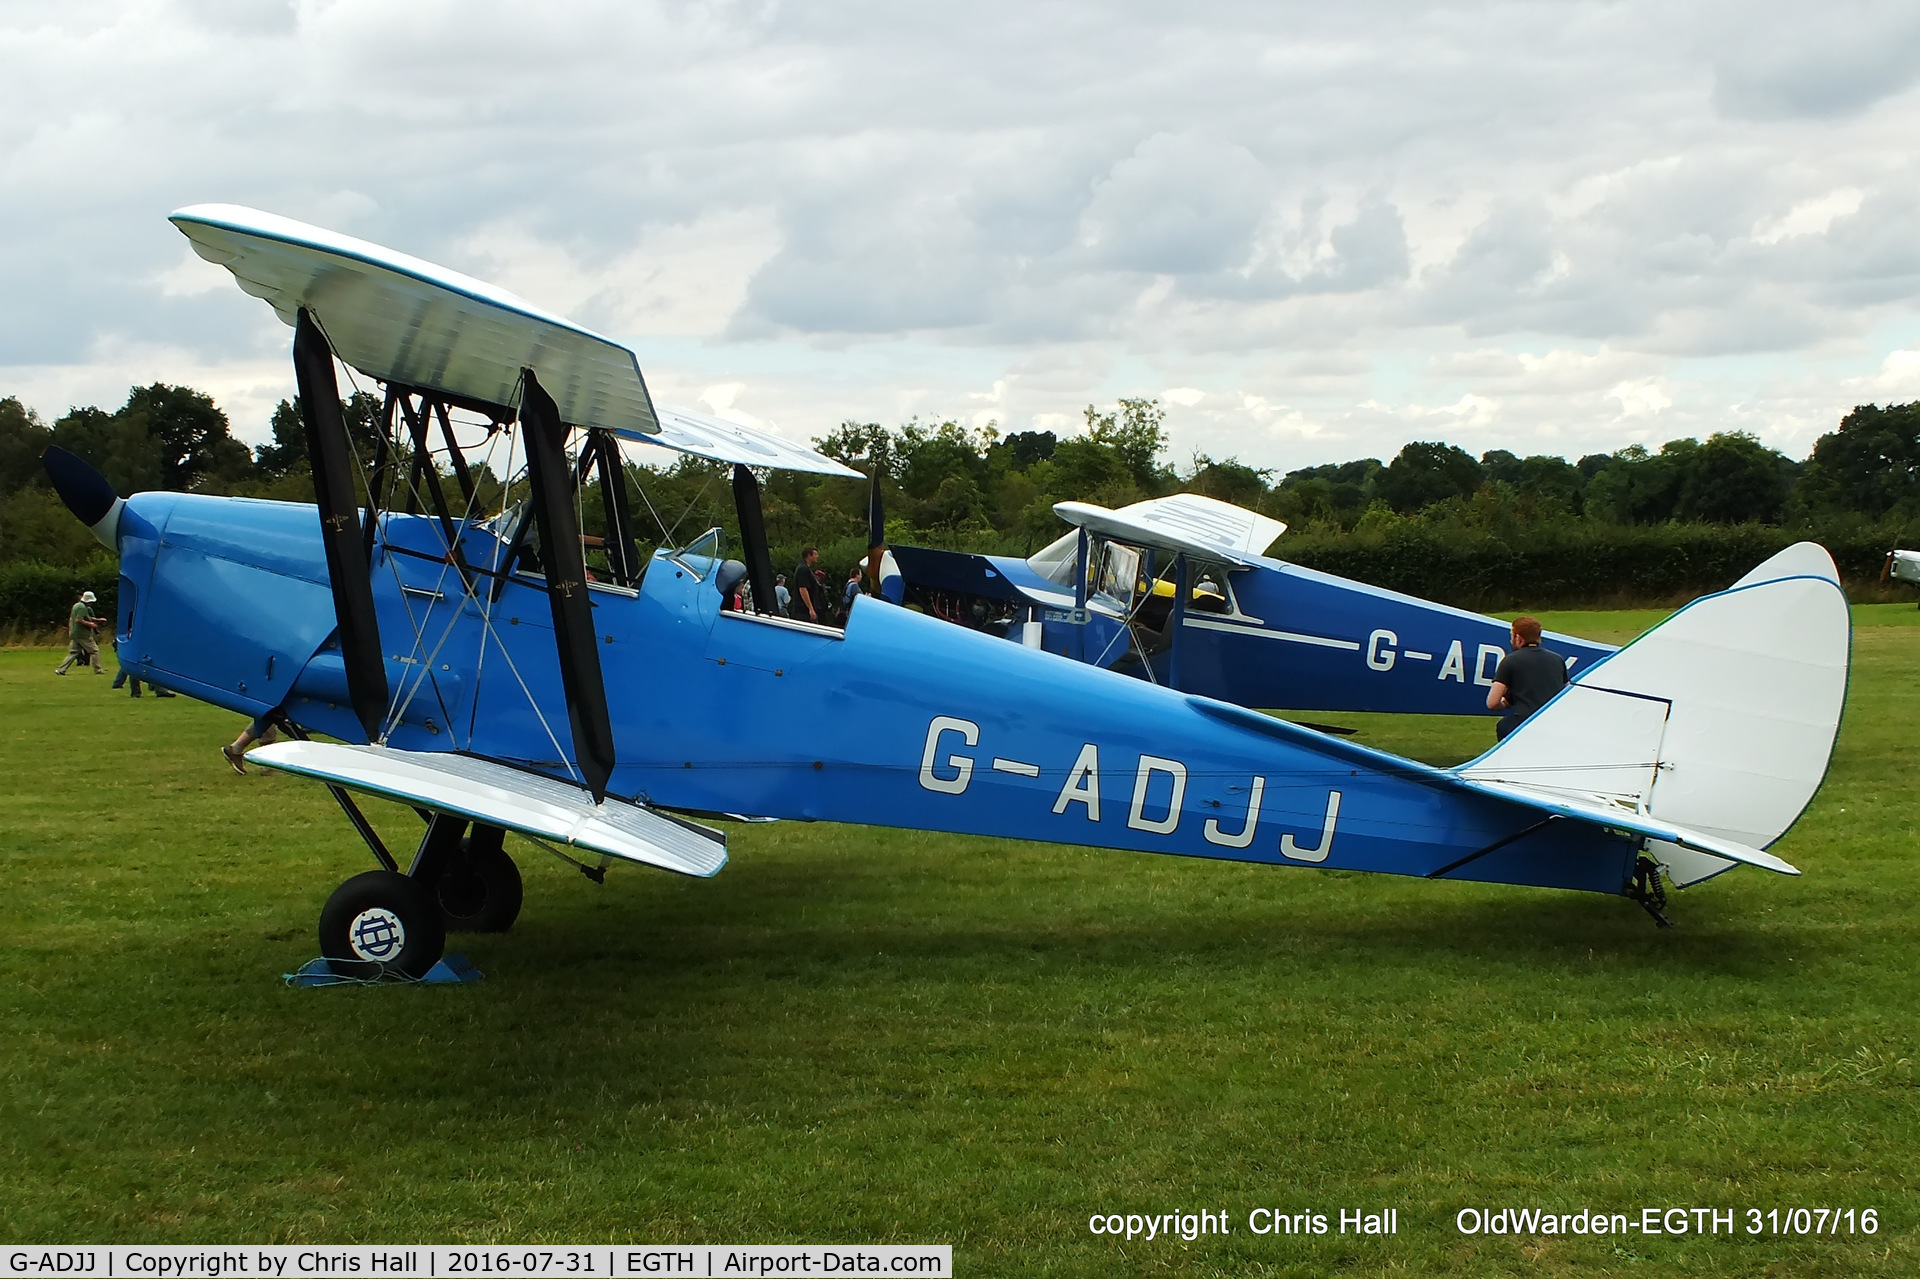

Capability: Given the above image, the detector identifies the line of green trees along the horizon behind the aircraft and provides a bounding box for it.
[0,382,1920,620]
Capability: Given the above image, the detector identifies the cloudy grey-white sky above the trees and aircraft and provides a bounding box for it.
[0,0,1920,471]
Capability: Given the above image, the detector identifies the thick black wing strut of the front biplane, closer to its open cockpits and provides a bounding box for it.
[520,369,614,803]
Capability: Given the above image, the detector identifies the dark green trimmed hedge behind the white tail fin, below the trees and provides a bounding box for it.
[1273,522,1893,609]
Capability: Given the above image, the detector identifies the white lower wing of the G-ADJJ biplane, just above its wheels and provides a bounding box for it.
[248,741,726,878]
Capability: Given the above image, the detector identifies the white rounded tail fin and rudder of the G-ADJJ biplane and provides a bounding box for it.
[1457,542,1853,883]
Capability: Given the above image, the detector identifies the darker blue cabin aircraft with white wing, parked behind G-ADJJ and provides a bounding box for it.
[895,494,1615,714]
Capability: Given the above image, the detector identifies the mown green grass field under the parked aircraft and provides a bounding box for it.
[0,605,1920,1275]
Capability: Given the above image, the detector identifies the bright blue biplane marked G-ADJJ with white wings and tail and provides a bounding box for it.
[46,205,1851,976]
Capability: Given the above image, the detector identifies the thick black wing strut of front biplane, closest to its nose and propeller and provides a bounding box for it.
[294,307,388,741]
